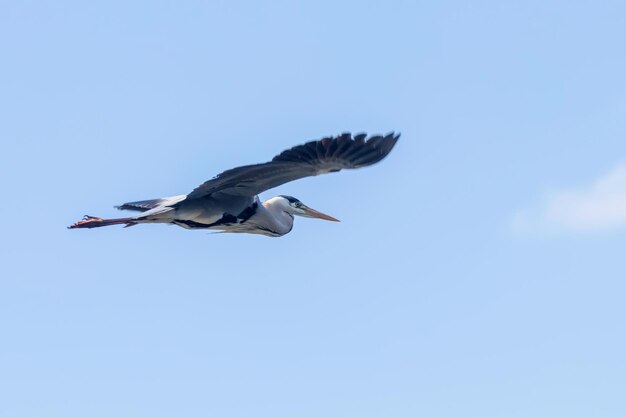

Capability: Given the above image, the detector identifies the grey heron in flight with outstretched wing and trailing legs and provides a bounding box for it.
[68,132,400,237]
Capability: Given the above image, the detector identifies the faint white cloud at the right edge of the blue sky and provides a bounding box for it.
[512,164,626,234]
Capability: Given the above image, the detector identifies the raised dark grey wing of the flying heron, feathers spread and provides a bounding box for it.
[187,132,400,199]
